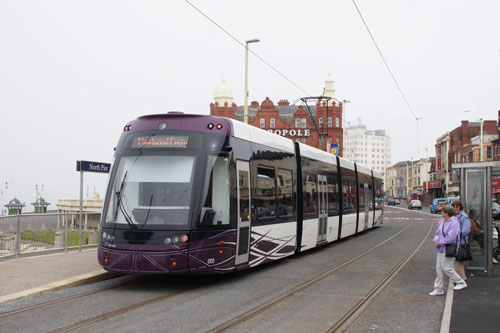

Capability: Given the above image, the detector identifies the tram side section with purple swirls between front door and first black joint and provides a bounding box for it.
[249,143,297,267]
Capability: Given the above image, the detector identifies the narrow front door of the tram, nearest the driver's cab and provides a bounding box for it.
[235,161,250,265]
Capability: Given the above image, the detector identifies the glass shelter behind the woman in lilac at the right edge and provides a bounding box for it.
[452,161,500,276]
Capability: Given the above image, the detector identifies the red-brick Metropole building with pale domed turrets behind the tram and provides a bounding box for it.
[210,75,343,156]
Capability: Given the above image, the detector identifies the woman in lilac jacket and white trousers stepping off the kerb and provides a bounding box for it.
[429,206,467,296]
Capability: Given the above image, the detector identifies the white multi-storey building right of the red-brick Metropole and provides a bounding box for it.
[343,125,391,180]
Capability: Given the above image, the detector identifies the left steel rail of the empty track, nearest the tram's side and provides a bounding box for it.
[208,221,415,333]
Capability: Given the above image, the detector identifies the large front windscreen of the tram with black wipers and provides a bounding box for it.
[105,155,196,229]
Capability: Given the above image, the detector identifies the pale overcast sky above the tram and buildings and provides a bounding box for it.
[0,0,500,211]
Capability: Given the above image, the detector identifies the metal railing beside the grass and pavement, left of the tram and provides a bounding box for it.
[0,212,101,258]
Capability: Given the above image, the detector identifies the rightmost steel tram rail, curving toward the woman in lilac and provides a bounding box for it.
[327,218,434,333]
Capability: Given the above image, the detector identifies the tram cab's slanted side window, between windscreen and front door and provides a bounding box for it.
[199,155,229,226]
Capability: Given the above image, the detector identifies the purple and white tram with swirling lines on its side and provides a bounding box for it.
[98,112,383,274]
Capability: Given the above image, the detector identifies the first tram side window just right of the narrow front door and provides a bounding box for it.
[255,167,276,218]
